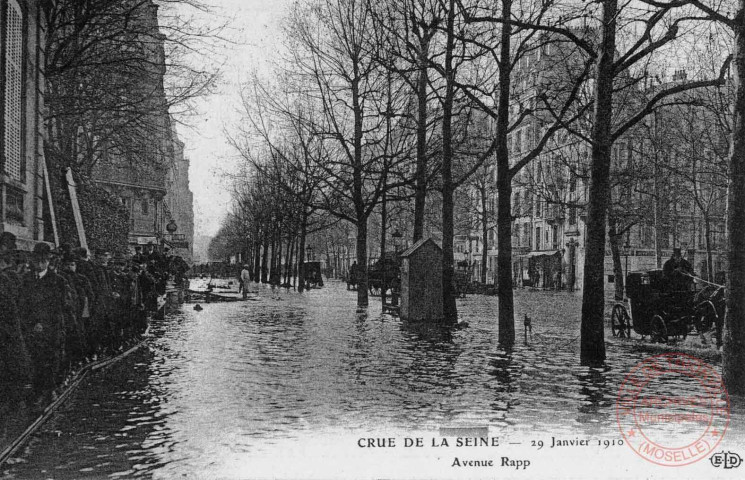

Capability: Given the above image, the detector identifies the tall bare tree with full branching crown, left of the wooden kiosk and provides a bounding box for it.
[287,0,416,307]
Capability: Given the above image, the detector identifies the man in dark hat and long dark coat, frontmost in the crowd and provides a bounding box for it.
[18,243,70,394]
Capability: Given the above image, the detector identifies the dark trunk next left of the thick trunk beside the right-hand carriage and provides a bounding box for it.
[496,0,515,350]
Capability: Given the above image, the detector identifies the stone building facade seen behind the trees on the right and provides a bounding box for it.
[455,32,728,290]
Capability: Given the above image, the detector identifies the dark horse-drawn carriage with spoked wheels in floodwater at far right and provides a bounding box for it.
[611,270,724,343]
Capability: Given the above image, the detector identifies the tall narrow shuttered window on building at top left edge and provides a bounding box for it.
[5,0,23,180]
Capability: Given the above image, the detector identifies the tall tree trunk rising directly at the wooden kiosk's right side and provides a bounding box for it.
[442,0,458,323]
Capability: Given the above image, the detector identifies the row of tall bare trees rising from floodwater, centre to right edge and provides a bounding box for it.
[215,0,745,391]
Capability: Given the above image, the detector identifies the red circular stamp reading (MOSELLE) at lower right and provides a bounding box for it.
[616,353,730,467]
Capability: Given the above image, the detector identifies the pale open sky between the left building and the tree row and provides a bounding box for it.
[171,0,291,236]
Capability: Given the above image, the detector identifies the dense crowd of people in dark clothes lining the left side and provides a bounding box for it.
[0,232,188,402]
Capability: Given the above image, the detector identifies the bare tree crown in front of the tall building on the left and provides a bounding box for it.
[44,0,220,179]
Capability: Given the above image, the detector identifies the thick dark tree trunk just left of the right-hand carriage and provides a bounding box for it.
[580,0,618,365]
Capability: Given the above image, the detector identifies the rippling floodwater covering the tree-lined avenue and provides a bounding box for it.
[0,281,745,478]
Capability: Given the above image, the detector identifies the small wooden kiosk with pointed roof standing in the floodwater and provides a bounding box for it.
[400,238,443,322]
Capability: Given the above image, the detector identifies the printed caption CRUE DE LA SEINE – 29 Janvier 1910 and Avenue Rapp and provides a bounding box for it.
[357,436,624,469]
